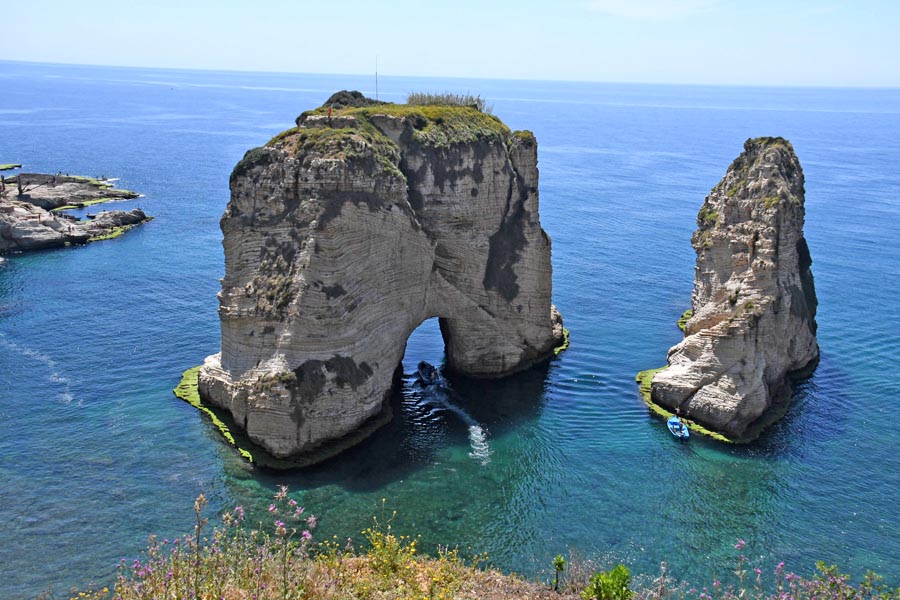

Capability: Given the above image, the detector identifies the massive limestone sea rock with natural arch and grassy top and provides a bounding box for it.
[200,95,562,460]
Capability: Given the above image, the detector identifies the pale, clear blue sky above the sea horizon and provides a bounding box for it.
[0,0,900,87]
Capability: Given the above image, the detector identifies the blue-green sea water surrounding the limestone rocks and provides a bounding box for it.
[0,62,900,598]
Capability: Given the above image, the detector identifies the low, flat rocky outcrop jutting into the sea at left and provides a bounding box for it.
[0,173,153,254]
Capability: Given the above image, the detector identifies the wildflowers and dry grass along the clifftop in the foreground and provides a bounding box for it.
[58,487,900,600]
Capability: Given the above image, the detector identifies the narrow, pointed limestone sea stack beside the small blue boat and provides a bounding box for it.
[651,138,819,440]
